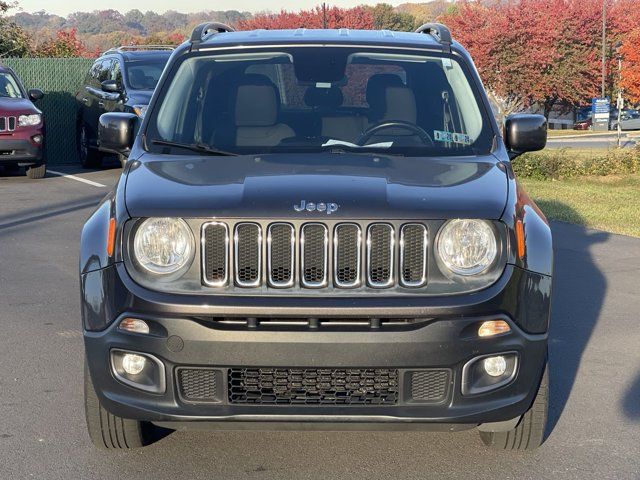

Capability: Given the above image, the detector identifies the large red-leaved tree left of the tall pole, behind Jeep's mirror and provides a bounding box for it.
[441,0,602,115]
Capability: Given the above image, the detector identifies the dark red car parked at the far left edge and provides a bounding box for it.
[0,65,47,178]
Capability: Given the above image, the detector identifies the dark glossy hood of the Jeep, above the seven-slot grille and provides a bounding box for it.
[125,154,508,220]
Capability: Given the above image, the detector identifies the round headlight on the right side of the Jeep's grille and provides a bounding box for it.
[437,220,498,275]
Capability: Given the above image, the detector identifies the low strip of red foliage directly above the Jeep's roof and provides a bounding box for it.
[237,7,374,30]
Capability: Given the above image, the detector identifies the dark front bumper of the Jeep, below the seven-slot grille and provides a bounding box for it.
[82,265,550,429]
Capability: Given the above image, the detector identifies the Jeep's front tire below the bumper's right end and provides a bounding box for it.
[479,366,549,451]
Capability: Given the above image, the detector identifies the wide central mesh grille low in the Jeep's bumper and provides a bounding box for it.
[228,368,398,405]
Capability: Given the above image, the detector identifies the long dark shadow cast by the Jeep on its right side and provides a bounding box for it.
[538,208,610,433]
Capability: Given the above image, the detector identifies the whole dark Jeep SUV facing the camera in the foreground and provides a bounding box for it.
[80,24,553,449]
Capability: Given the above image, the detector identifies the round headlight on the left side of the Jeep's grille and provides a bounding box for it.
[133,218,195,274]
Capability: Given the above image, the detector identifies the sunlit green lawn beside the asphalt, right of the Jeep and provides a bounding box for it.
[519,174,640,237]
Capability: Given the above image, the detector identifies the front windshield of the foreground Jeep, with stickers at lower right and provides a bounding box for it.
[146,46,493,156]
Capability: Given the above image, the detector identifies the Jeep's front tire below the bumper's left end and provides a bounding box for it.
[84,363,169,450]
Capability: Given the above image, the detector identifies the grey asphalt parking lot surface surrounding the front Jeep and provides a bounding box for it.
[0,167,640,480]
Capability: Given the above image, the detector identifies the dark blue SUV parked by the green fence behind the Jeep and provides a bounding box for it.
[76,45,173,168]
